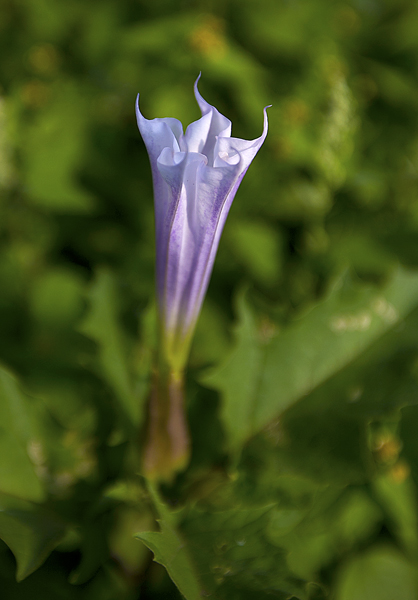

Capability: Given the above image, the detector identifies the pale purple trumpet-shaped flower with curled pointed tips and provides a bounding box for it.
[136,76,267,372]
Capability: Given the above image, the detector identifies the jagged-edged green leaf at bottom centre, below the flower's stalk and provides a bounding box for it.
[136,482,305,600]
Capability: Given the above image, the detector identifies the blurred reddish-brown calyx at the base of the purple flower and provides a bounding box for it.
[143,359,190,481]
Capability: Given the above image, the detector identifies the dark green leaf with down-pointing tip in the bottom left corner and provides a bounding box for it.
[0,496,65,581]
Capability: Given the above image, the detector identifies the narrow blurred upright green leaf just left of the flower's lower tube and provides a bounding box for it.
[80,269,141,424]
